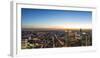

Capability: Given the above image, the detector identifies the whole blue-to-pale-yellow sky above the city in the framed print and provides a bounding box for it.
[21,8,92,28]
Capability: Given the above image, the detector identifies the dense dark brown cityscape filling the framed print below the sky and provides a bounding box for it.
[21,29,92,49]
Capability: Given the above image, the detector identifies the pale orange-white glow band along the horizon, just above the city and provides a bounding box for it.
[22,23,92,29]
